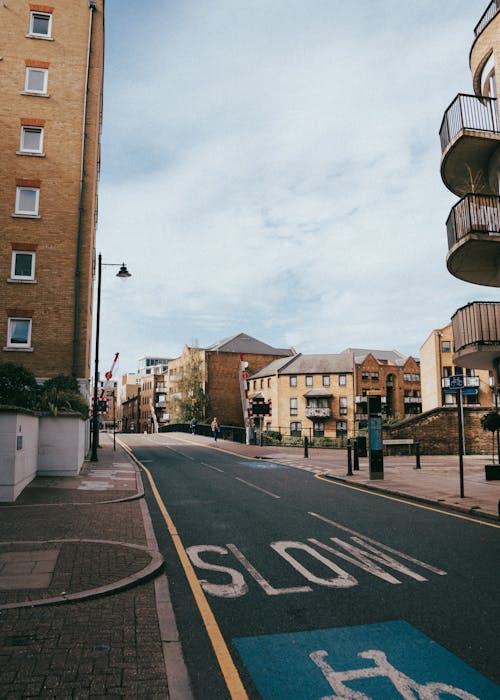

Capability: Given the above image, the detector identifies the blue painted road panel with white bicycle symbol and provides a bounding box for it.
[233,620,500,700]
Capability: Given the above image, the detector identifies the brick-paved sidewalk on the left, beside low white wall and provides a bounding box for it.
[0,434,192,700]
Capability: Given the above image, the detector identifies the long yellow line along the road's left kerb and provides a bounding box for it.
[117,439,248,700]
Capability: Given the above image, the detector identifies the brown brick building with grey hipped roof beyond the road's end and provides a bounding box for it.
[166,333,296,426]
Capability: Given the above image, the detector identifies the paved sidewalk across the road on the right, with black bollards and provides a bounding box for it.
[166,433,500,521]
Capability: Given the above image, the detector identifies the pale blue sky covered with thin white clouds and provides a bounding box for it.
[97,0,498,373]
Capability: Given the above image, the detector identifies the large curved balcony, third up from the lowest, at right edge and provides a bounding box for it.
[439,95,500,197]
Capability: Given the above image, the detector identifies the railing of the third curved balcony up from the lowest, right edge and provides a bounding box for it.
[439,94,500,153]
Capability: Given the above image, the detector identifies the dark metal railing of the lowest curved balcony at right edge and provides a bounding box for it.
[451,301,500,353]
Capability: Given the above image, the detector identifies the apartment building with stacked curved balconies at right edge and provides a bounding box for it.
[440,0,500,387]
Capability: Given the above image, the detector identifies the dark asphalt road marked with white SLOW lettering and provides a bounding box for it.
[123,435,500,700]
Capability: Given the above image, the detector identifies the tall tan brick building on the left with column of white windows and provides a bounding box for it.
[0,0,104,394]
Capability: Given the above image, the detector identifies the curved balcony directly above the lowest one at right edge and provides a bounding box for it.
[446,194,500,287]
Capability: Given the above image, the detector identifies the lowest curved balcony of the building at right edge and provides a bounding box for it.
[451,301,500,369]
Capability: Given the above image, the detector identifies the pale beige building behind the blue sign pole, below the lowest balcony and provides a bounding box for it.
[420,323,494,411]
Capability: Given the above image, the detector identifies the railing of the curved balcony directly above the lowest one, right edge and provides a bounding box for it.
[446,194,500,249]
